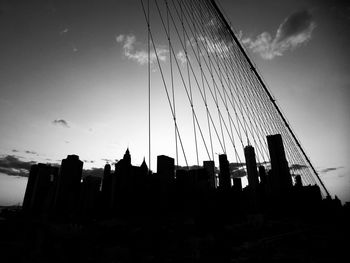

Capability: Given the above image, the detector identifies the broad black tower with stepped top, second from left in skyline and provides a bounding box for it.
[54,155,83,215]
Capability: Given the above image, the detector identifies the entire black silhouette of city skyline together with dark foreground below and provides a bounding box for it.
[0,134,350,262]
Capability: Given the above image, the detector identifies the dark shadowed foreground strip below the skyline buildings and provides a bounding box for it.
[0,205,350,262]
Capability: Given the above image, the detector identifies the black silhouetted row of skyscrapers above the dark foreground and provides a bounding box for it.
[23,134,321,220]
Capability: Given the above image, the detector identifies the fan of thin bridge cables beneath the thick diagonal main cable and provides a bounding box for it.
[143,0,329,196]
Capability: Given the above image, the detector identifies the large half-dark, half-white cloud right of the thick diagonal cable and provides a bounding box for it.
[242,10,316,60]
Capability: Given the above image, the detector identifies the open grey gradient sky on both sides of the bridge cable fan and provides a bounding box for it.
[0,0,350,205]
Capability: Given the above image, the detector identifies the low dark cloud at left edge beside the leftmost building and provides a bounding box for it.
[0,155,35,177]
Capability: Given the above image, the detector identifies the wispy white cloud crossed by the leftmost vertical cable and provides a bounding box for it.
[116,34,169,65]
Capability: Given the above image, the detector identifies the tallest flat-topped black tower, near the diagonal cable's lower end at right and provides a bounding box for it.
[266,134,292,194]
